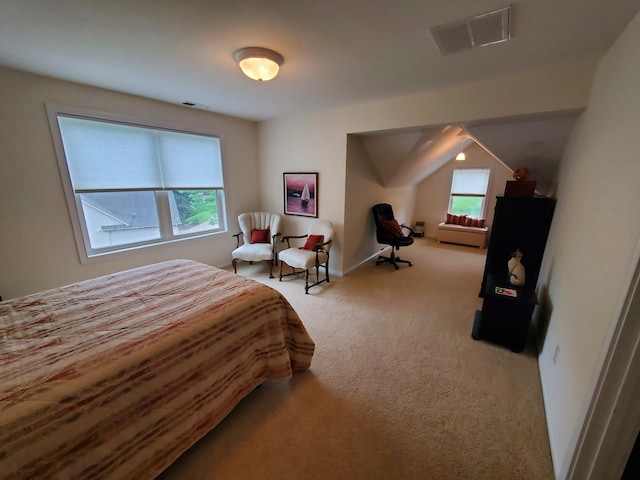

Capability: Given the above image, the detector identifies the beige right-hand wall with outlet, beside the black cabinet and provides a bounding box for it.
[539,10,640,479]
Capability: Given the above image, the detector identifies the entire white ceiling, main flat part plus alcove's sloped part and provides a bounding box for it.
[0,0,640,186]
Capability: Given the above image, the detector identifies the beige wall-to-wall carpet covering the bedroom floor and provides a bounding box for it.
[160,239,553,480]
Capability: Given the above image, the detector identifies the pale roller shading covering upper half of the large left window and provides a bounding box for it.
[58,116,223,192]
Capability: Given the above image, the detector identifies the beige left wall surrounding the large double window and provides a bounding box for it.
[0,68,260,298]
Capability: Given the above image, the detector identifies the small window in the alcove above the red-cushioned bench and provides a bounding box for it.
[449,168,490,218]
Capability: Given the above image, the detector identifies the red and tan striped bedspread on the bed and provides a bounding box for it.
[0,260,314,480]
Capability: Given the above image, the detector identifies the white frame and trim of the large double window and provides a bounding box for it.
[45,103,228,264]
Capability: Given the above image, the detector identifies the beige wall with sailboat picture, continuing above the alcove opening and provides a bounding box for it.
[259,63,596,273]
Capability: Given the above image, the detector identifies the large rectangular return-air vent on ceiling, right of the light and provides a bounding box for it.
[431,6,511,55]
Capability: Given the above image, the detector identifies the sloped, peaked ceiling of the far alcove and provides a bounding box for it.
[357,110,582,195]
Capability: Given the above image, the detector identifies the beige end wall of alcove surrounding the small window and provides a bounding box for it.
[412,144,512,238]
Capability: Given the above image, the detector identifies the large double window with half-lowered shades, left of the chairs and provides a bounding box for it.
[50,108,225,260]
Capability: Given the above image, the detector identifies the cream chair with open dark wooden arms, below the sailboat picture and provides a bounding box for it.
[278,220,333,293]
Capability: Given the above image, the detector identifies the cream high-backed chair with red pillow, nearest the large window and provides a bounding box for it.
[231,212,282,278]
